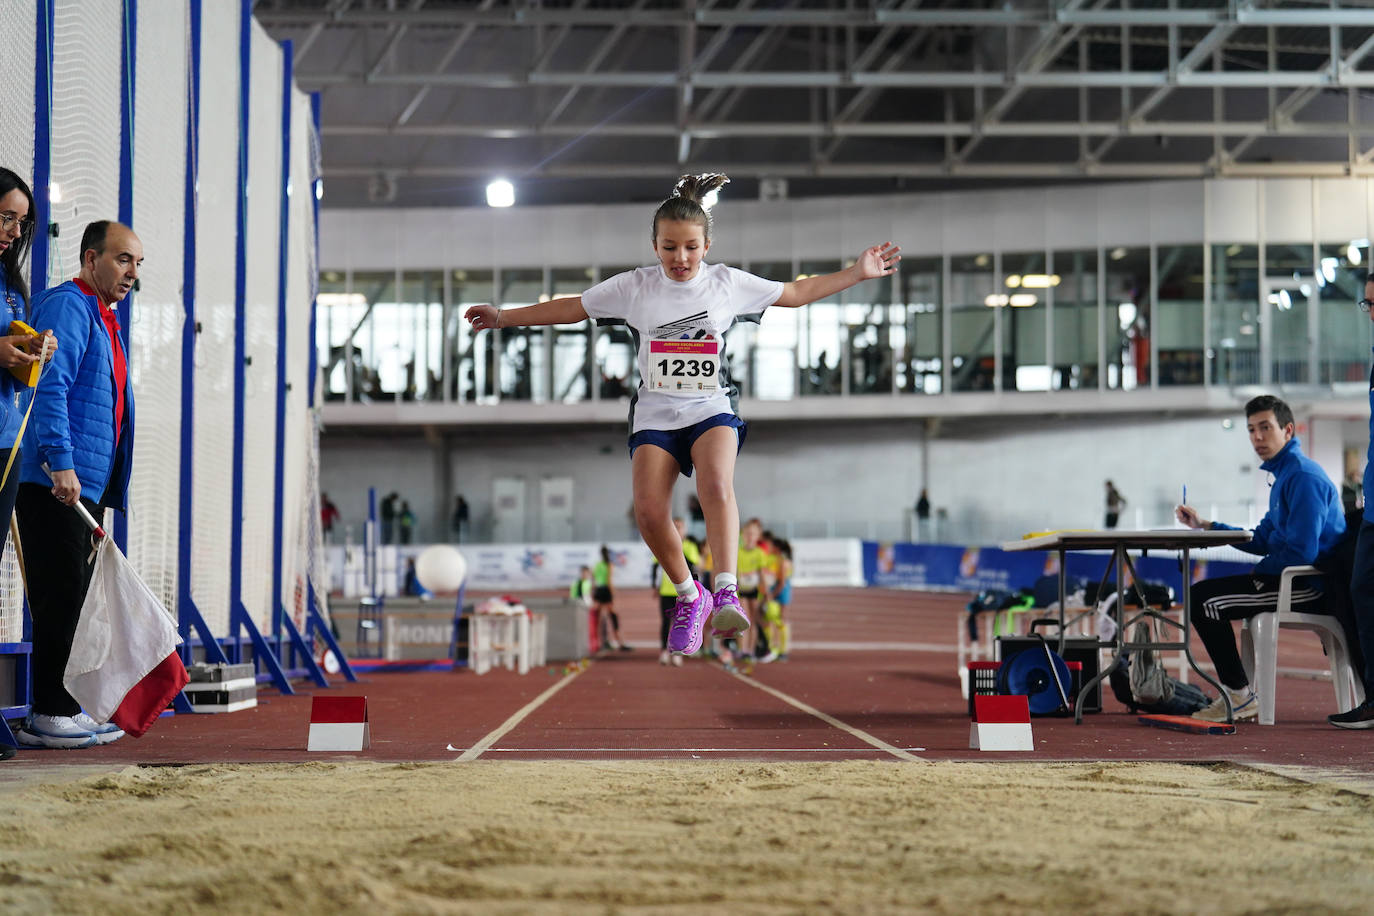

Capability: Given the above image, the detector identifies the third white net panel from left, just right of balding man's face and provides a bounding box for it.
[128,0,190,608]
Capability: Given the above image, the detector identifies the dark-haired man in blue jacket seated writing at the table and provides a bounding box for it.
[1176,394,1345,722]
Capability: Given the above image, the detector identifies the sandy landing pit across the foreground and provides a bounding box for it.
[0,761,1374,913]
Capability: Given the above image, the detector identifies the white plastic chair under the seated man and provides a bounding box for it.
[1241,566,1364,725]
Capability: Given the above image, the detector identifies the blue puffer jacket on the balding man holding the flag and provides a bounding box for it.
[19,280,133,509]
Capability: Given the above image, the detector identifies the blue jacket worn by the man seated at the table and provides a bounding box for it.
[1212,435,1345,575]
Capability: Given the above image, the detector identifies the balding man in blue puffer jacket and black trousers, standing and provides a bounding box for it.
[16,220,143,747]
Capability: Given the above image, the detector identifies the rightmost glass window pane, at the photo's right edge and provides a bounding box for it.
[1316,239,1370,385]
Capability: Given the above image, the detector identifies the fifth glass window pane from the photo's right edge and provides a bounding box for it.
[1102,246,1153,389]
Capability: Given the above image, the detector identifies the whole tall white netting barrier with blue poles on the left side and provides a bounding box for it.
[0,0,327,692]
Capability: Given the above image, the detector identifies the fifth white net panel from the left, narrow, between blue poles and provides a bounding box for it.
[242,23,286,633]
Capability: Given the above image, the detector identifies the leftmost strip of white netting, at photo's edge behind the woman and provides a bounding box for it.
[0,0,37,643]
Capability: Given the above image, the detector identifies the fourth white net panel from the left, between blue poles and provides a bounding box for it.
[191,3,241,636]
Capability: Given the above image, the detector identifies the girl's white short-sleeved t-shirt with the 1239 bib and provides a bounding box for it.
[583,261,783,433]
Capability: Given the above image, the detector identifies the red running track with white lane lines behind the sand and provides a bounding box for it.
[0,589,1374,779]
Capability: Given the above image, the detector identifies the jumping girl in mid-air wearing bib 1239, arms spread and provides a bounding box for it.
[464,174,901,655]
